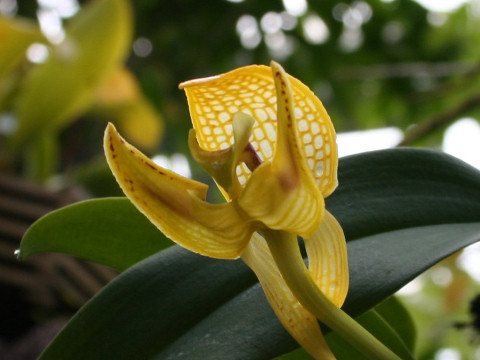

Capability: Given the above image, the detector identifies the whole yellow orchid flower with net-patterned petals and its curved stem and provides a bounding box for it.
[105,62,398,359]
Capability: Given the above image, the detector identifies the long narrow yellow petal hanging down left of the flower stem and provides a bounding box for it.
[242,234,335,360]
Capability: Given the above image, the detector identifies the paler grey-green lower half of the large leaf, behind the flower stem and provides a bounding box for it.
[154,222,480,359]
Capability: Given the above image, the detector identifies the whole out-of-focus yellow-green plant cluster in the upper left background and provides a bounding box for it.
[0,0,163,181]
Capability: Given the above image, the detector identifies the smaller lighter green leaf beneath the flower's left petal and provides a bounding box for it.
[20,198,173,270]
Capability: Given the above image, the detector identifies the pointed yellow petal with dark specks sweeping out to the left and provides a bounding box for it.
[104,124,252,259]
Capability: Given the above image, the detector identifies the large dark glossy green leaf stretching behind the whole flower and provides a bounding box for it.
[24,149,480,360]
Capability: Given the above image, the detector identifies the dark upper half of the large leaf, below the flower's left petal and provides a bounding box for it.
[39,246,258,360]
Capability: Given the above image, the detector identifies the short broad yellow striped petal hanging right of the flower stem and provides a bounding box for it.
[304,211,349,307]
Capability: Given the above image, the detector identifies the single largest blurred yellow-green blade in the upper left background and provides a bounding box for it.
[11,0,132,150]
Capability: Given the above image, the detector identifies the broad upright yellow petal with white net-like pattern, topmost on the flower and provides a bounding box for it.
[180,65,338,197]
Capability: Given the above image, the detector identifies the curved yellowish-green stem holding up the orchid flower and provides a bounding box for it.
[262,229,400,360]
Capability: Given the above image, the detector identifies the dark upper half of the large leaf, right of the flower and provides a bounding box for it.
[326,148,480,241]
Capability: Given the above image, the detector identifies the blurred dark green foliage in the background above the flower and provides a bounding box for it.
[0,0,480,173]
